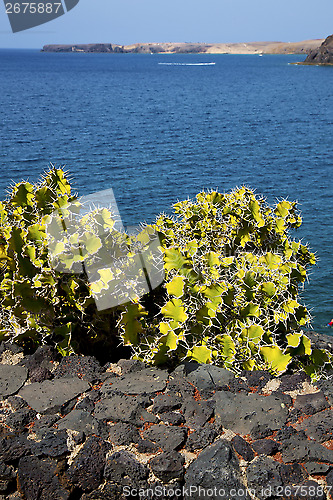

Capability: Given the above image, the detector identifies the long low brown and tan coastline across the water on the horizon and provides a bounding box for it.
[42,39,323,54]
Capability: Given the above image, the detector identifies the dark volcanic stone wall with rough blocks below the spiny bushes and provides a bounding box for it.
[0,334,333,500]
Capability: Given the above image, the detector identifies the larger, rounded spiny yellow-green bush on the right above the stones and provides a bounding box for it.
[120,187,332,377]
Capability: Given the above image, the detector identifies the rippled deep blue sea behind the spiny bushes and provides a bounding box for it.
[0,50,333,334]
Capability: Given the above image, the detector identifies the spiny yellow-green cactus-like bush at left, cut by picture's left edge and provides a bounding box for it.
[0,167,125,356]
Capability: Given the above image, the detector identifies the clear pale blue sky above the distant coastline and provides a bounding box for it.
[0,0,333,48]
